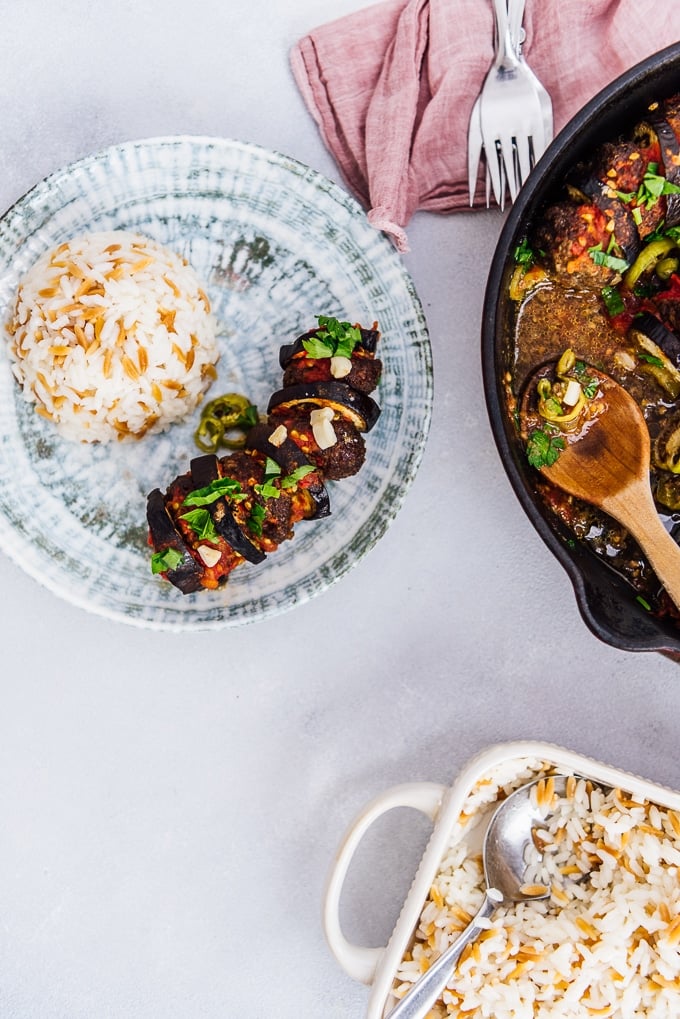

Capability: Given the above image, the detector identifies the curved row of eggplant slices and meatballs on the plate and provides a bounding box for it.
[147,316,382,594]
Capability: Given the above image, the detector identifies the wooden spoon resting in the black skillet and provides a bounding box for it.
[520,365,680,608]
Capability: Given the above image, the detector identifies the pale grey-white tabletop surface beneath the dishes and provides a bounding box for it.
[0,0,680,1019]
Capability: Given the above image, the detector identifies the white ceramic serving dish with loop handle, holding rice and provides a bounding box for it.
[323,741,680,1019]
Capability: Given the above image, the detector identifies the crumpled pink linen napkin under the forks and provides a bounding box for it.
[291,0,680,252]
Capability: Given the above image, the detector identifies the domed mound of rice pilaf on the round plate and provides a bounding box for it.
[6,230,218,442]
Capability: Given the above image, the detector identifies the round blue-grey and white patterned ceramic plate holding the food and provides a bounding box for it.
[0,138,432,630]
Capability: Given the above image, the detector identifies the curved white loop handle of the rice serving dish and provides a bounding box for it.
[323,782,447,983]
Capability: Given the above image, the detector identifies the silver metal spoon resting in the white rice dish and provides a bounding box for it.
[386,776,567,1019]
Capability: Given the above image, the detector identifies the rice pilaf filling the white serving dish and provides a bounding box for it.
[394,760,680,1019]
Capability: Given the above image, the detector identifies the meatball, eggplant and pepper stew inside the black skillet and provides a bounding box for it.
[507,96,680,624]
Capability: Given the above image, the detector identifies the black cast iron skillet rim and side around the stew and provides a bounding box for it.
[482,43,680,656]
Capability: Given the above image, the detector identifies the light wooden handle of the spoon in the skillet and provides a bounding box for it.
[603,482,680,608]
